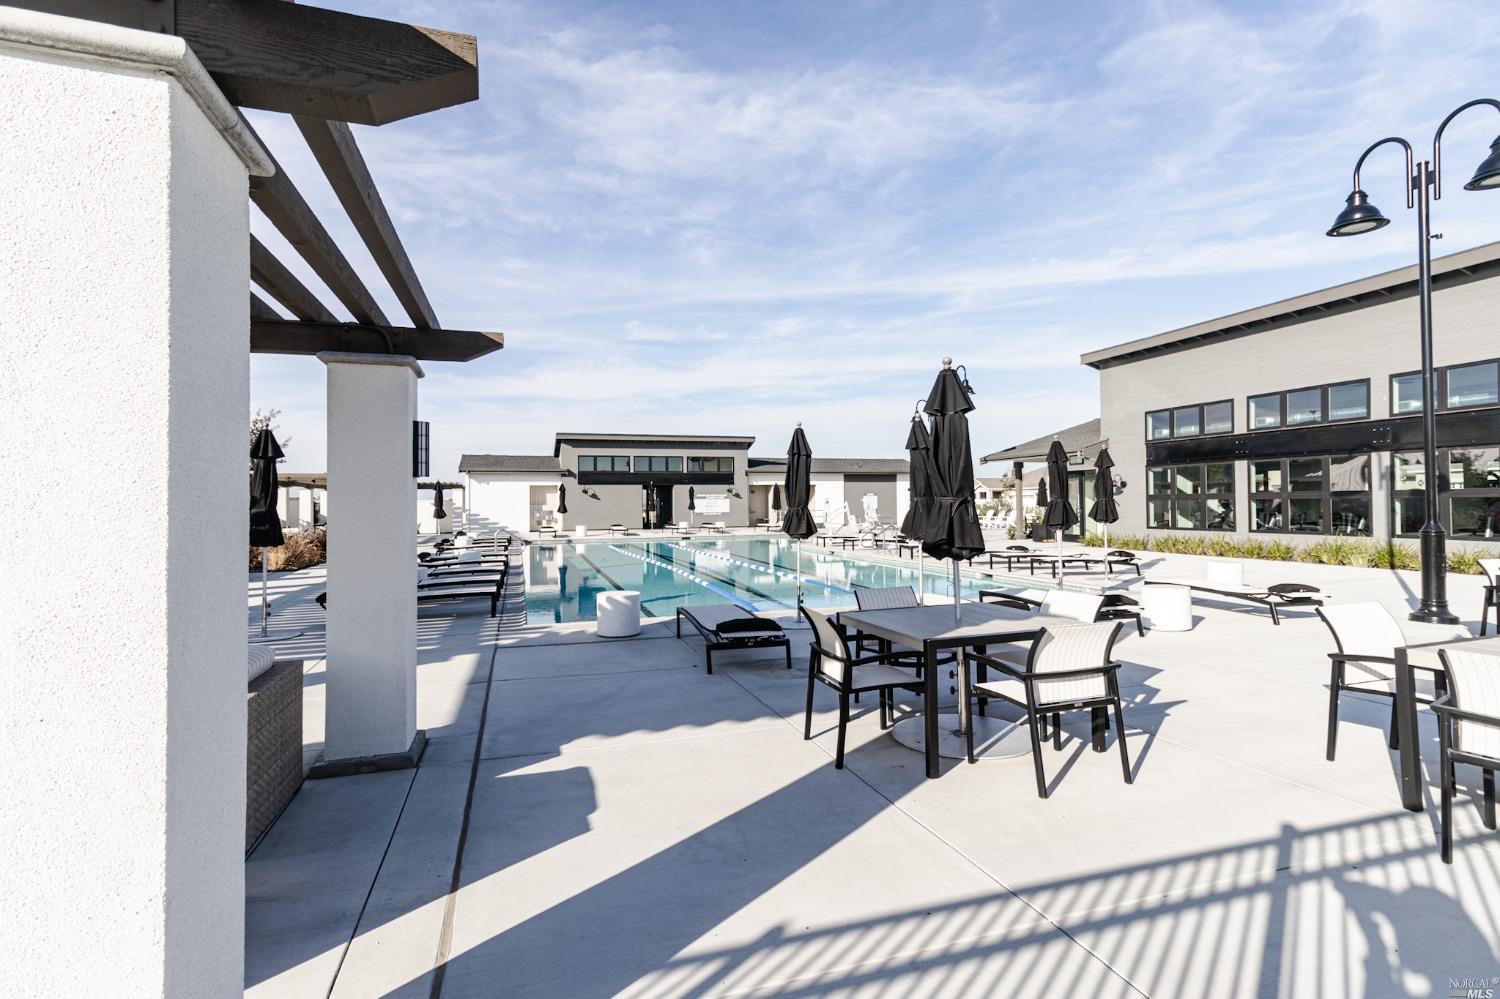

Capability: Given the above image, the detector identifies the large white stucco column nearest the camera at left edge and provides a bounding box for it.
[0,8,270,996]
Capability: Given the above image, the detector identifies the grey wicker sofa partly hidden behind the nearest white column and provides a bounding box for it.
[245,645,303,852]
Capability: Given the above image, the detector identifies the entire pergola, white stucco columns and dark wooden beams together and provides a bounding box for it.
[0,0,504,996]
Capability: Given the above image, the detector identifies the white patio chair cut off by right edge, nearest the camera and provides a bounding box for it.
[1433,648,1500,864]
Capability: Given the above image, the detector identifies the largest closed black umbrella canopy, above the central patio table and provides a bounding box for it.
[923,359,984,560]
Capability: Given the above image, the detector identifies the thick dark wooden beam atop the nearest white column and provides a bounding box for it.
[20,0,479,125]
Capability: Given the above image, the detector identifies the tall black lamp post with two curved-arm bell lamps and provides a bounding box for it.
[1328,98,1500,624]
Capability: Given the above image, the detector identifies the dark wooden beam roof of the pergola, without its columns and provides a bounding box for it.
[27,0,506,362]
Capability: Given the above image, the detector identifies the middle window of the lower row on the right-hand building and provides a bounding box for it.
[1250,455,1370,537]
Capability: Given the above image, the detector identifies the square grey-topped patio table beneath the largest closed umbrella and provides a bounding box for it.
[839,602,1077,777]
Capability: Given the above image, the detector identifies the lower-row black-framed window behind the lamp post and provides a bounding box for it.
[1391,447,1500,539]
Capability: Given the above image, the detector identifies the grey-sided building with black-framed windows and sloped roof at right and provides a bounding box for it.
[1080,243,1500,545]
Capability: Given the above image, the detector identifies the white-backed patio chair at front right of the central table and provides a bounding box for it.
[963,621,1136,798]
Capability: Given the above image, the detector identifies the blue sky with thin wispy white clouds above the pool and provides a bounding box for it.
[252,0,1500,474]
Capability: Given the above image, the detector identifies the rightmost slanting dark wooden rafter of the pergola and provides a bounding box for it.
[296,114,440,330]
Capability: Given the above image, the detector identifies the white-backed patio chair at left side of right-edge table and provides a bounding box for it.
[1317,602,1469,761]
